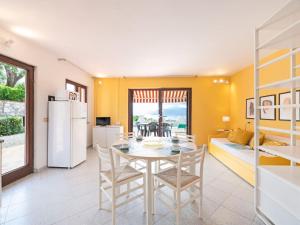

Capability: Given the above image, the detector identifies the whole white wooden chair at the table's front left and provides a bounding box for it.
[96,145,146,225]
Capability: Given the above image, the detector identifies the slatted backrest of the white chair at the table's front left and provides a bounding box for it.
[96,144,115,180]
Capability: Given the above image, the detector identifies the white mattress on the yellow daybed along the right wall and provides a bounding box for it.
[211,138,273,166]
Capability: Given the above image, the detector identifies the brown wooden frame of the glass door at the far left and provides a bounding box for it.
[0,54,34,186]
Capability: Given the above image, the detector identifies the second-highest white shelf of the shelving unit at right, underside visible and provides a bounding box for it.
[257,20,300,50]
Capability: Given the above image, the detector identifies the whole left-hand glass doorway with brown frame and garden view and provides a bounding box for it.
[0,55,34,186]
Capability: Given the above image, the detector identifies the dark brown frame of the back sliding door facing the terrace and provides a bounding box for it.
[128,88,192,136]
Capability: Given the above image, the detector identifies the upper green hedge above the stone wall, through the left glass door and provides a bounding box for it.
[0,84,25,102]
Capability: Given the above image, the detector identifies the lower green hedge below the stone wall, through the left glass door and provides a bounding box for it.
[0,116,24,137]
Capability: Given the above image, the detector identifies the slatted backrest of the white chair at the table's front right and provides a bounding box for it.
[177,145,205,188]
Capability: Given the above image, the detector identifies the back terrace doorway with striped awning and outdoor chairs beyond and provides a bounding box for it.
[128,88,192,137]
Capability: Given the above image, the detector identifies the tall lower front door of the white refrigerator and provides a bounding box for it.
[71,119,87,167]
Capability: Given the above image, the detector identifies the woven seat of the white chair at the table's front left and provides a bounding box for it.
[102,165,143,183]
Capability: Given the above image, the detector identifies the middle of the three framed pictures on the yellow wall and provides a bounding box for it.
[259,95,276,120]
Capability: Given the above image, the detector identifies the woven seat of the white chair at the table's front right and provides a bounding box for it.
[155,168,200,188]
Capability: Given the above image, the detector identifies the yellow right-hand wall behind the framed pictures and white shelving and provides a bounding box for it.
[230,51,299,132]
